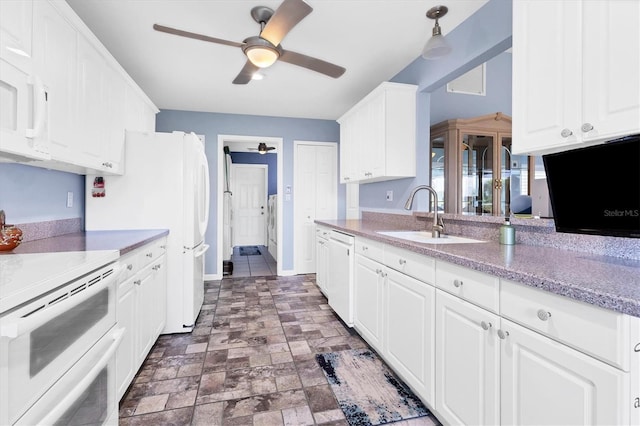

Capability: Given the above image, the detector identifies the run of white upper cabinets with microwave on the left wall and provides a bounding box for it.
[0,0,157,174]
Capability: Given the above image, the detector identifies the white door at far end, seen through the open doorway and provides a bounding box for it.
[231,164,268,246]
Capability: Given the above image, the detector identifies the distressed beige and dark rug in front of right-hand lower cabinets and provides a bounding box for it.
[316,349,440,426]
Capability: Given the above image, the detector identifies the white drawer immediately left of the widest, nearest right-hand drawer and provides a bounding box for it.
[436,261,500,313]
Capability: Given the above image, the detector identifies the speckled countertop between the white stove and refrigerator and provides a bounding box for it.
[0,229,169,256]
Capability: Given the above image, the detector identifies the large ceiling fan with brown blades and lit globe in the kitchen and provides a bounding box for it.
[153,0,345,84]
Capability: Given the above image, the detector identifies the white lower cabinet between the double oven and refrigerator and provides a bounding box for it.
[116,238,167,399]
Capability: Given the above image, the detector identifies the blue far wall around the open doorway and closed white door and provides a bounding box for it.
[156,110,345,275]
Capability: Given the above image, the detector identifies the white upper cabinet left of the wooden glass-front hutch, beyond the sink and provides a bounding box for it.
[338,82,417,183]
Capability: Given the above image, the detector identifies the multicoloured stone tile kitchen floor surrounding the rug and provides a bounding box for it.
[119,275,440,426]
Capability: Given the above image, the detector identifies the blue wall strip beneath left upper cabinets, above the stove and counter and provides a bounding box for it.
[0,163,84,223]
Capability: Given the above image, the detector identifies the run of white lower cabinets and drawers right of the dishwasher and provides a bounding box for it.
[353,238,640,425]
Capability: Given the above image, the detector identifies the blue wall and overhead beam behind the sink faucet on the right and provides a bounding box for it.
[360,0,512,210]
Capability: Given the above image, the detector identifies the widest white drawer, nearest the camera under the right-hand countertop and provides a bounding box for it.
[500,280,631,371]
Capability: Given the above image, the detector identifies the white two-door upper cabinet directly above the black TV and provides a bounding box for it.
[513,0,640,154]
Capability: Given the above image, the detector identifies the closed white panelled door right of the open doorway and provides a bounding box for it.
[294,142,338,274]
